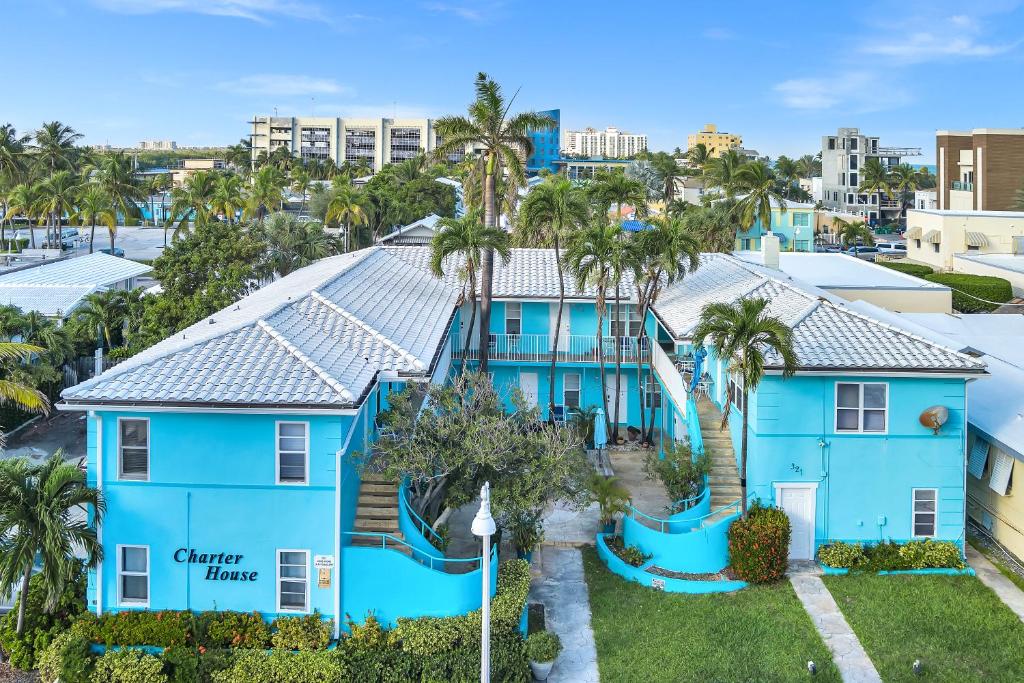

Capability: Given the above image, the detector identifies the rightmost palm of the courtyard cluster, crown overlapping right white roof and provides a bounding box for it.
[634,216,700,441]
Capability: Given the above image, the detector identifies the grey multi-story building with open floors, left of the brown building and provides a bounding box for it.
[821,128,921,223]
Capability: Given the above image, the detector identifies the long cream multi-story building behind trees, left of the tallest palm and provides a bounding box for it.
[249,116,465,173]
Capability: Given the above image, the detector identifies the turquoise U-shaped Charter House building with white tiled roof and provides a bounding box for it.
[60,246,984,630]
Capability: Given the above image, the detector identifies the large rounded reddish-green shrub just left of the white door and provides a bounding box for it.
[729,502,790,584]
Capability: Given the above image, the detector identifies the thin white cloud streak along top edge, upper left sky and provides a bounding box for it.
[93,0,328,24]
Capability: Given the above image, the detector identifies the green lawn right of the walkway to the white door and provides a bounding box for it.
[824,574,1024,683]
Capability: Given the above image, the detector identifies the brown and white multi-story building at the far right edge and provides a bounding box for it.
[935,128,1024,211]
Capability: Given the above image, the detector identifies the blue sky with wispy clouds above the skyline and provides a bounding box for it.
[0,0,1024,163]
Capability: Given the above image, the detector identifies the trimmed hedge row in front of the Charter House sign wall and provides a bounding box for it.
[39,560,529,683]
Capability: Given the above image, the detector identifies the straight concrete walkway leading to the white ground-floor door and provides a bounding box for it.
[788,563,882,683]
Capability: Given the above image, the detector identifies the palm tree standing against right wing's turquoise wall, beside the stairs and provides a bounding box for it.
[693,298,798,517]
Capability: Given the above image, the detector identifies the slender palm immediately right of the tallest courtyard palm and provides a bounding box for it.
[513,176,590,420]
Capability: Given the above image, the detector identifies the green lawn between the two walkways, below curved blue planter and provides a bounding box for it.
[584,549,840,683]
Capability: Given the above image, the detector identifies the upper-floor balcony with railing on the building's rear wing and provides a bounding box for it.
[452,334,650,362]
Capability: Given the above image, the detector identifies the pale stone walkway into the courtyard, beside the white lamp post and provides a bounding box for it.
[529,546,600,683]
